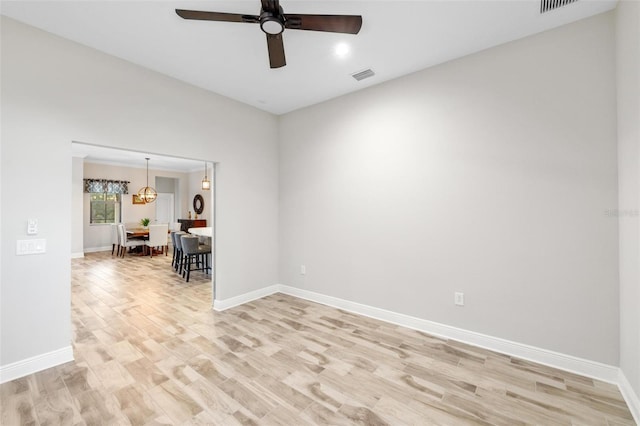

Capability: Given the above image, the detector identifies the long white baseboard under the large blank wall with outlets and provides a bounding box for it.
[279,285,619,384]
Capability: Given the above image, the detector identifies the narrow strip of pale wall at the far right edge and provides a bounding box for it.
[616,1,640,399]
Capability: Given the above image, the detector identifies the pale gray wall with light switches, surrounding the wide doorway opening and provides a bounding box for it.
[0,17,278,367]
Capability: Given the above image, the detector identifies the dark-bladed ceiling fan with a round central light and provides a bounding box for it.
[176,0,362,68]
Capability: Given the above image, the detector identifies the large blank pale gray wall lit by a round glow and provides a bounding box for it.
[279,13,619,365]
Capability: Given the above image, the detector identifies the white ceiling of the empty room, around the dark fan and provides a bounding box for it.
[0,0,616,114]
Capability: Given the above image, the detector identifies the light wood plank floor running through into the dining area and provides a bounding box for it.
[0,253,634,426]
